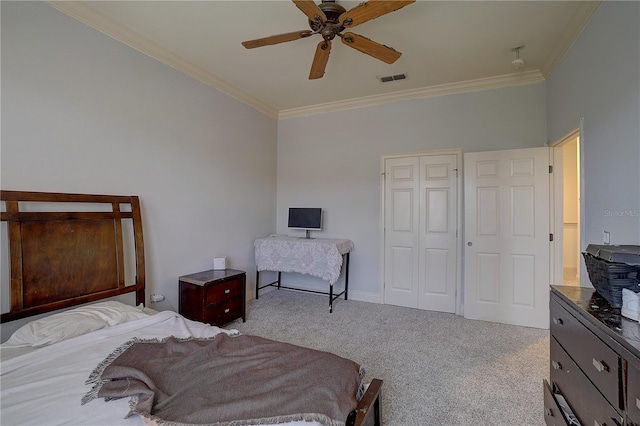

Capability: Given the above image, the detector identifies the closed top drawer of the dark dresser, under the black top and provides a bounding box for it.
[551,300,623,409]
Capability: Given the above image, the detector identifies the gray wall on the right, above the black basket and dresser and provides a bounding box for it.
[547,1,640,249]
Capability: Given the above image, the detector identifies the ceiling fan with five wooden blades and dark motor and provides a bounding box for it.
[242,0,416,80]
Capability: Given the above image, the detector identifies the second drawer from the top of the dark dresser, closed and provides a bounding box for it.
[550,338,622,426]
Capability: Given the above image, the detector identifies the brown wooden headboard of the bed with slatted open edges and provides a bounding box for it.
[0,191,145,323]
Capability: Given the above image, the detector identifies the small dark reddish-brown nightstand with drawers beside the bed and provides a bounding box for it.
[178,269,246,326]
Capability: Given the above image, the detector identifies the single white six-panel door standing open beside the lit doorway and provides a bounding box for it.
[464,148,549,328]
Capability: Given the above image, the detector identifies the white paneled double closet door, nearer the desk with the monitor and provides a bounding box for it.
[384,154,458,312]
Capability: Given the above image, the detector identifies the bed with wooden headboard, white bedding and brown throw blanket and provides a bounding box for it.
[0,191,382,426]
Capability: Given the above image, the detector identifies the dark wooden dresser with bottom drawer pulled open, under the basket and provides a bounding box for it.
[544,286,640,426]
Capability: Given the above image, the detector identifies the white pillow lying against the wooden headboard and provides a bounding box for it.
[3,301,148,347]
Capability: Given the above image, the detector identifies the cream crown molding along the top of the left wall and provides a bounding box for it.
[46,0,278,119]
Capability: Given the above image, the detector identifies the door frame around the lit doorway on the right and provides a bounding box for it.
[548,122,588,287]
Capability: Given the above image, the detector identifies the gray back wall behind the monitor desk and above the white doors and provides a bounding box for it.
[277,83,546,301]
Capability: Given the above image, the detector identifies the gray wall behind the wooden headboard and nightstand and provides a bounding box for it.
[0,1,277,337]
